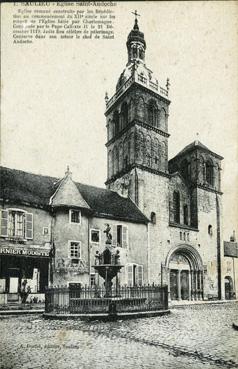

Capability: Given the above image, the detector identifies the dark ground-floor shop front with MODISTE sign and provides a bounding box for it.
[0,245,50,304]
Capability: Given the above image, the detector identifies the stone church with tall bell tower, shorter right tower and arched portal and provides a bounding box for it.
[105,16,227,299]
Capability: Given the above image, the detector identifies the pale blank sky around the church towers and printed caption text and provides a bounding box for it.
[1,1,238,238]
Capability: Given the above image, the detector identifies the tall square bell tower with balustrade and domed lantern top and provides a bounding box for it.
[105,12,170,220]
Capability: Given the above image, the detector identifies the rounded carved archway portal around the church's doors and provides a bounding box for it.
[165,244,203,300]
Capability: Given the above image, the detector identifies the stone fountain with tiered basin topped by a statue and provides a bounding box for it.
[93,224,124,297]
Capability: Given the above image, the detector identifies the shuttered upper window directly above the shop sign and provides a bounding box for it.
[1,209,33,239]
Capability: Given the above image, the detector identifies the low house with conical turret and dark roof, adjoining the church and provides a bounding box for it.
[0,168,149,303]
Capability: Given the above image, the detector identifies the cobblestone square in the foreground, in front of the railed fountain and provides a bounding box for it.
[0,302,238,369]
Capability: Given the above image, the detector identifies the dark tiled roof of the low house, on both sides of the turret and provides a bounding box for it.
[0,167,148,223]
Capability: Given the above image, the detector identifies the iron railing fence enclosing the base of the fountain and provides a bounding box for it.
[45,285,168,314]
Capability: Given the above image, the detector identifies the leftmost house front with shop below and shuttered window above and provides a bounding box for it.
[0,202,52,304]
